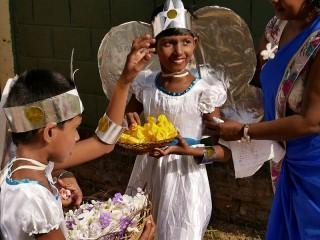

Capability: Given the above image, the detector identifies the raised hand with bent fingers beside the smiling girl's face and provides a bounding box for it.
[121,34,156,82]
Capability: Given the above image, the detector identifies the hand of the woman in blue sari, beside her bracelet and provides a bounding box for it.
[204,119,244,141]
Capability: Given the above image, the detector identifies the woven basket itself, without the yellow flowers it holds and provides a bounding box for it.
[117,138,175,155]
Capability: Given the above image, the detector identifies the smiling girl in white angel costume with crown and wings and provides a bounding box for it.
[99,0,260,240]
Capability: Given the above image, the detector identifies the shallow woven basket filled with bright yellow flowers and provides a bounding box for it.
[117,114,178,154]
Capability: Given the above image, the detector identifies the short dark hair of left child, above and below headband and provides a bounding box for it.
[4,69,75,145]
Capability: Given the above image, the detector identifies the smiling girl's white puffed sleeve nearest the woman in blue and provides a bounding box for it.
[199,78,227,114]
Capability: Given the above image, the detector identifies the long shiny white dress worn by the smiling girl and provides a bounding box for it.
[127,72,226,240]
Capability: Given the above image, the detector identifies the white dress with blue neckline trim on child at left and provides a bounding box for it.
[0,163,65,240]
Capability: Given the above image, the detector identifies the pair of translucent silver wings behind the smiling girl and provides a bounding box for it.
[98,6,263,122]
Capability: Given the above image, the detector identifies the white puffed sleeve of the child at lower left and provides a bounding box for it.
[14,184,64,236]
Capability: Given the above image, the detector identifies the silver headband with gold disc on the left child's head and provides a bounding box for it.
[3,89,84,133]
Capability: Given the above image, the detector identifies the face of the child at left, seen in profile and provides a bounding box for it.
[51,116,82,162]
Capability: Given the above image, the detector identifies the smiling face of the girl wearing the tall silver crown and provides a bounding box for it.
[157,34,197,73]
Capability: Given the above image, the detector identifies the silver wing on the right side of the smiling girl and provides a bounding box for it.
[192,6,263,122]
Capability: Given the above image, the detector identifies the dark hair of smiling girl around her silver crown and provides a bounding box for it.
[151,4,195,42]
